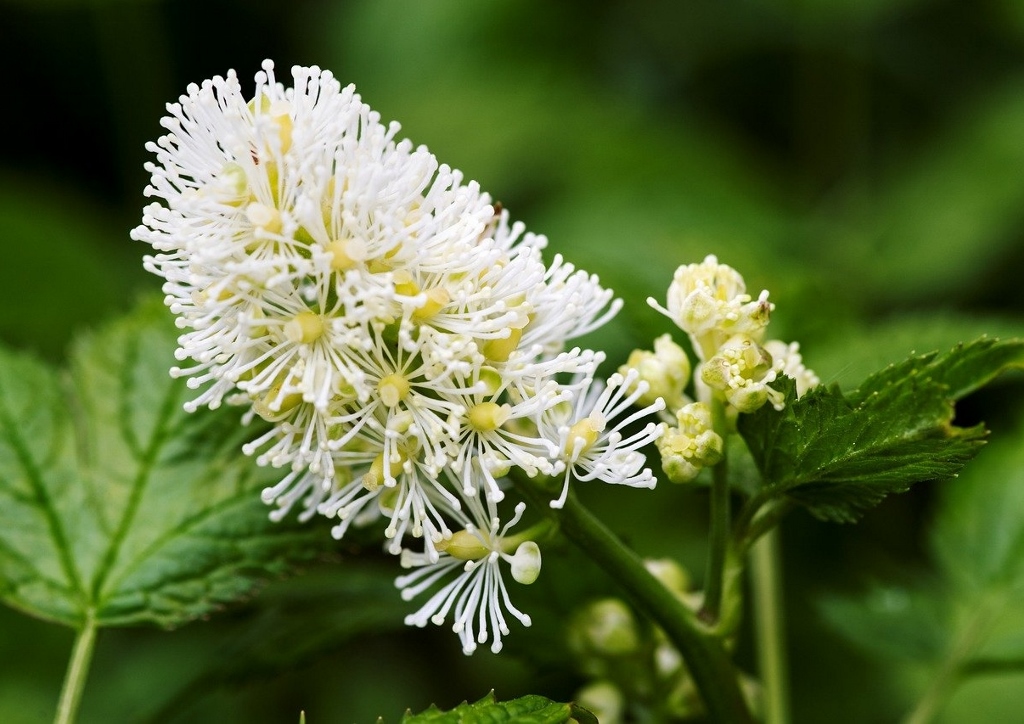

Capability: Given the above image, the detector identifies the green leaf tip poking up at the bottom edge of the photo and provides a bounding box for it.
[401,691,597,724]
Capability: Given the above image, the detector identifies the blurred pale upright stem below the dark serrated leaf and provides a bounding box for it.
[751,528,790,724]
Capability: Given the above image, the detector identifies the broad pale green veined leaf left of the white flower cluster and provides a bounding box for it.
[0,305,323,627]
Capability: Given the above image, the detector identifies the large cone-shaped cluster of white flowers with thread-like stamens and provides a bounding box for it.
[132,61,664,651]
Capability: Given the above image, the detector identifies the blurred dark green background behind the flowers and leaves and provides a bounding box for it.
[6,0,1024,724]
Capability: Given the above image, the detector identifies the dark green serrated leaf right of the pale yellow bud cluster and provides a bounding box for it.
[738,339,1024,522]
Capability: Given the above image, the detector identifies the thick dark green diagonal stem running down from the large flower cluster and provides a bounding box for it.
[516,480,754,724]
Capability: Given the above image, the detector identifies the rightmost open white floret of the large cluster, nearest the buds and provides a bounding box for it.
[541,370,665,508]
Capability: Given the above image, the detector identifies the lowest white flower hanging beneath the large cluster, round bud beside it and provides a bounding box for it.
[395,499,541,654]
